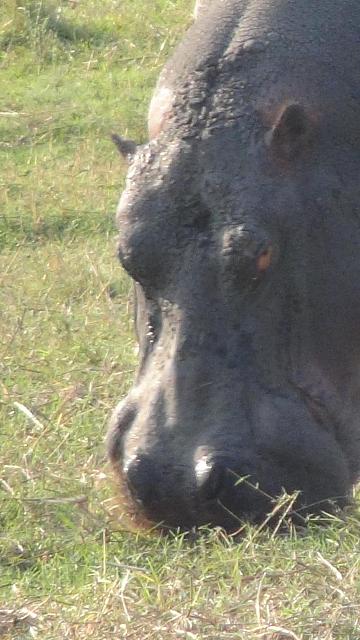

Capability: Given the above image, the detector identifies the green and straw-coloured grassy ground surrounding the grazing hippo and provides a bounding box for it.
[0,0,360,640]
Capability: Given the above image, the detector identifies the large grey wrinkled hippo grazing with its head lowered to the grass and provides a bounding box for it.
[107,0,360,532]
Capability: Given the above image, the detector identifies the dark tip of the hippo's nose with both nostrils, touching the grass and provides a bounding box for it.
[123,453,271,530]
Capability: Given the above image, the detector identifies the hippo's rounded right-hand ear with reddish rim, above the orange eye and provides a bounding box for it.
[267,104,313,160]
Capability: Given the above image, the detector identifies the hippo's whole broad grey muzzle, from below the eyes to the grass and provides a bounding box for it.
[108,302,350,531]
